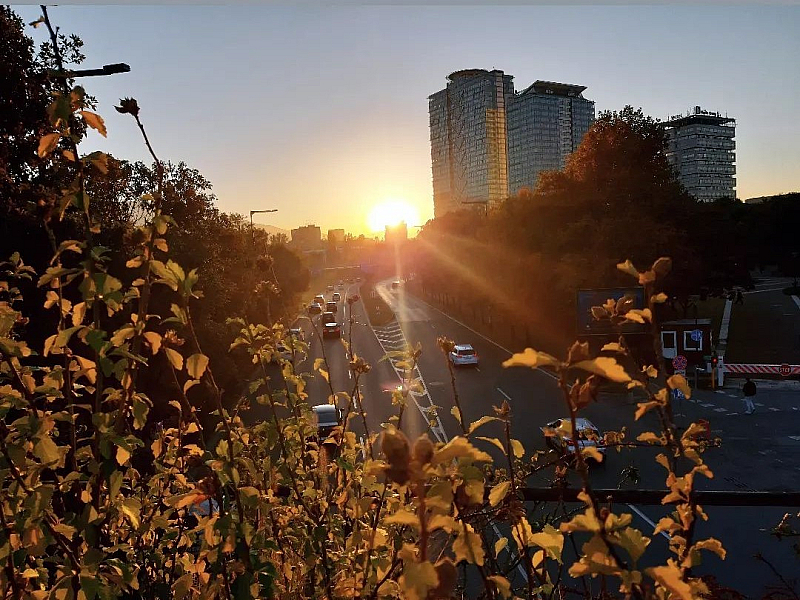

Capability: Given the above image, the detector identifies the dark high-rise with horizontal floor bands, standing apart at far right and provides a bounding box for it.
[663,106,736,202]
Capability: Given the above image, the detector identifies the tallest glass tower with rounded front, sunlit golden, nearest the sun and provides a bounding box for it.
[428,69,514,217]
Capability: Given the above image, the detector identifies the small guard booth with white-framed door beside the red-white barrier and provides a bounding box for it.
[661,319,714,375]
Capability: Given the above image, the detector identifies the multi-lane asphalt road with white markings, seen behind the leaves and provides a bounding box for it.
[244,282,800,597]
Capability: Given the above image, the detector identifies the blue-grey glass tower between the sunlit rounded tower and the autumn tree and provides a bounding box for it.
[507,81,594,195]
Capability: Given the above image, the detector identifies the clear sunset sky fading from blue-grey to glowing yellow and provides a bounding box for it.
[13,4,800,234]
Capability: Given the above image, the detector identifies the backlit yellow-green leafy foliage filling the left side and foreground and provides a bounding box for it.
[0,9,796,600]
